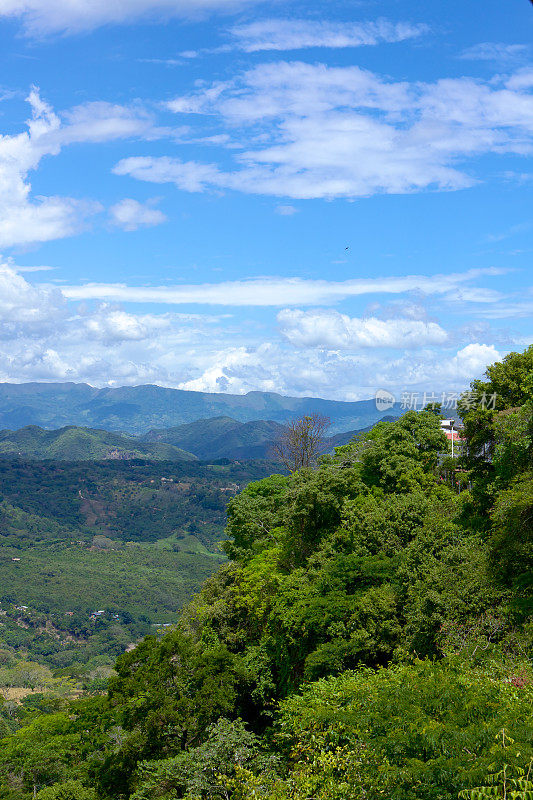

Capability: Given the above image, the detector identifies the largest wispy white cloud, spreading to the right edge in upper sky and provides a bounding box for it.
[118,62,533,199]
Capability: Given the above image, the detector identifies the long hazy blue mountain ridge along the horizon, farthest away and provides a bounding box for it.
[0,383,401,434]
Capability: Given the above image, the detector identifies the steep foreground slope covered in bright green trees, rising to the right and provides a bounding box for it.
[0,347,533,800]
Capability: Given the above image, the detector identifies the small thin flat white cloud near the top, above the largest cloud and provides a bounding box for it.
[230,19,428,53]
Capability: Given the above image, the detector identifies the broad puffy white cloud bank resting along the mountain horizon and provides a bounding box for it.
[0,263,512,400]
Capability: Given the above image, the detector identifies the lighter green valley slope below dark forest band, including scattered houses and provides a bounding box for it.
[0,496,222,676]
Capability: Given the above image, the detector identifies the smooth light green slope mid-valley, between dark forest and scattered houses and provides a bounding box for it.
[0,532,222,620]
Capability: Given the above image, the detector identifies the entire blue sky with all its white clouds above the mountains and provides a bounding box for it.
[0,0,533,399]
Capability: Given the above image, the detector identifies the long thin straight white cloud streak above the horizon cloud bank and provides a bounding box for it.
[58,267,505,306]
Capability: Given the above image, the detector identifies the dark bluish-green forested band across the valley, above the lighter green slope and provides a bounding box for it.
[0,459,280,550]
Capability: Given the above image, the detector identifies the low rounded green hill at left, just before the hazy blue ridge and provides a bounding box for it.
[0,425,195,461]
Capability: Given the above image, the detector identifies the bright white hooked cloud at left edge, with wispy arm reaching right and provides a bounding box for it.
[0,88,169,247]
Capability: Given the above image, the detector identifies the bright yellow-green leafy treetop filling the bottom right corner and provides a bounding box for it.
[266,659,533,800]
